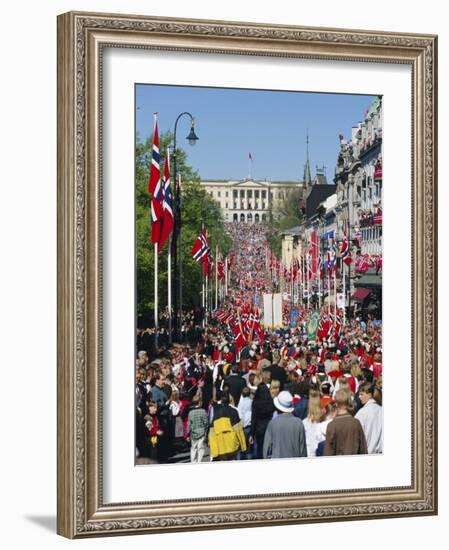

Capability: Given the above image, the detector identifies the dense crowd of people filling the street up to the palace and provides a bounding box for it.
[136,224,383,463]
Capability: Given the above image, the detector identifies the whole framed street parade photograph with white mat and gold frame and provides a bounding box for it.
[57,12,437,538]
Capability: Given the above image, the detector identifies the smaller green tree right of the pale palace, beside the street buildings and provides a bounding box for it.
[268,188,304,257]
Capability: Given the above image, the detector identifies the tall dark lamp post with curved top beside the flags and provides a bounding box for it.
[170,111,198,341]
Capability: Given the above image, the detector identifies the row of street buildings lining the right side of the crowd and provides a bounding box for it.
[282,97,383,318]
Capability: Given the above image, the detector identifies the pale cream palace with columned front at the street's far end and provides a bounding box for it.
[201,179,304,223]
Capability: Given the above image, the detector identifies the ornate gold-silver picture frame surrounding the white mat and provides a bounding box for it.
[57,12,437,538]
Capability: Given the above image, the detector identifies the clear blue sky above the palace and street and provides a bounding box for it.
[136,84,374,183]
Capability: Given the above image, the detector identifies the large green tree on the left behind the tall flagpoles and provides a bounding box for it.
[136,133,232,314]
